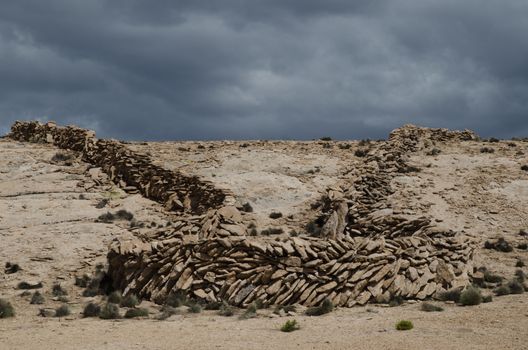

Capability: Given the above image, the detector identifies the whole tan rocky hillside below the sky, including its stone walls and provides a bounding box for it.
[0,123,528,349]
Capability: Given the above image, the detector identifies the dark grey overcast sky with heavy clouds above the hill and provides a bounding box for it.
[0,0,528,140]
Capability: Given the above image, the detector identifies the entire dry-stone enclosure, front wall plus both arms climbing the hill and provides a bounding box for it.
[9,122,476,307]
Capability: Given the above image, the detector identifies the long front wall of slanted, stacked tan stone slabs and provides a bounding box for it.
[108,227,473,307]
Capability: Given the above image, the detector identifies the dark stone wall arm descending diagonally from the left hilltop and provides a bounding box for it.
[9,122,232,214]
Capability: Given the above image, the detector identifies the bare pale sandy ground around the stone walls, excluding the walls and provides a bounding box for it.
[0,139,528,350]
